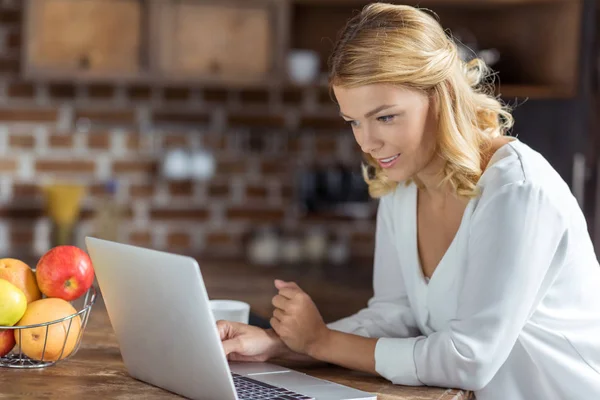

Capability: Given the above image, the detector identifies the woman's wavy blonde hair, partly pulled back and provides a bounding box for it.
[329,3,513,198]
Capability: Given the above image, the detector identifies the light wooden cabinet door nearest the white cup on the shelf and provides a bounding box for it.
[152,0,282,82]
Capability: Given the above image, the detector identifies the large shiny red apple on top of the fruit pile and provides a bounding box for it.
[35,245,94,301]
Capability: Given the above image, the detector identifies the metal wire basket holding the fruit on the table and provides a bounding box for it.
[0,286,96,368]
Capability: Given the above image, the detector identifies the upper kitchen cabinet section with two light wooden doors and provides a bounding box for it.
[23,0,286,84]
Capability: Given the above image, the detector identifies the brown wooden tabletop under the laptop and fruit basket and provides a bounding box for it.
[0,264,468,400]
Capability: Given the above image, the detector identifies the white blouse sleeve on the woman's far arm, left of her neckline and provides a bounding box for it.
[328,198,420,338]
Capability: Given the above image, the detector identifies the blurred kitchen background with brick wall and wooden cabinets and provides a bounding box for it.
[0,0,600,312]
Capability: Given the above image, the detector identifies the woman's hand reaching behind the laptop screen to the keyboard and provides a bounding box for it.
[217,320,286,362]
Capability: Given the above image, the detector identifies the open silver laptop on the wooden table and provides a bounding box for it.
[85,237,377,400]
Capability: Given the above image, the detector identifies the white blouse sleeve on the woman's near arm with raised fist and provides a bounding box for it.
[375,182,567,390]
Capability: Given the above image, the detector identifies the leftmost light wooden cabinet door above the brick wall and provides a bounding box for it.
[24,0,142,78]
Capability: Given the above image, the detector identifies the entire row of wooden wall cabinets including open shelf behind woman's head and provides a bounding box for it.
[23,0,585,99]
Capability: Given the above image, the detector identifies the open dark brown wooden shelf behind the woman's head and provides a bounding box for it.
[290,0,582,98]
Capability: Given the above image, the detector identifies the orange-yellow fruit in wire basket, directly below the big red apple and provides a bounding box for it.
[15,298,81,361]
